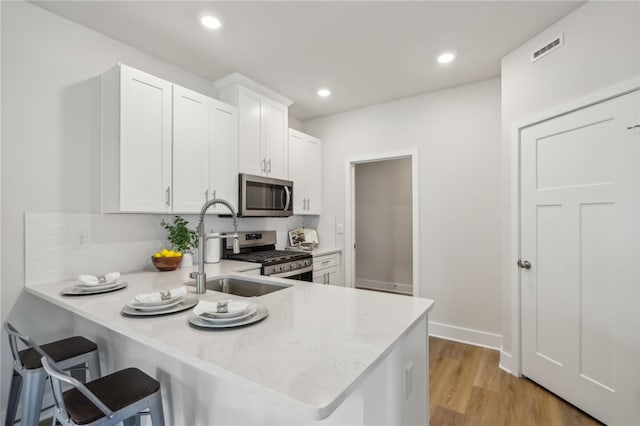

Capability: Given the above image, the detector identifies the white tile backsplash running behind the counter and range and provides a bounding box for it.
[25,213,335,285]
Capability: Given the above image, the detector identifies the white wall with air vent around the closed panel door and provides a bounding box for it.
[502,1,640,364]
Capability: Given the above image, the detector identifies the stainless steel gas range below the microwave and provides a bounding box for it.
[224,231,313,282]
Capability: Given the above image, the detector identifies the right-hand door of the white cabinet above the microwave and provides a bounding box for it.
[263,99,289,179]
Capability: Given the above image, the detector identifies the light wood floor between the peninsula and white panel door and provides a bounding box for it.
[429,337,602,426]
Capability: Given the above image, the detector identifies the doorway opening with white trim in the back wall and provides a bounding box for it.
[345,151,419,296]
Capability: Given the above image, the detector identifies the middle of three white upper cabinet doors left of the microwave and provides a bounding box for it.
[173,85,210,213]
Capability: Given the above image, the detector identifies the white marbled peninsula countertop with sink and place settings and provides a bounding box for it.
[26,260,433,419]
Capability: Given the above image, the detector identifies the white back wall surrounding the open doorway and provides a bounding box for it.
[305,79,502,346]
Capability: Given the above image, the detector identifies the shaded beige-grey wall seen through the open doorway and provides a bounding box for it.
[355,158,413,293]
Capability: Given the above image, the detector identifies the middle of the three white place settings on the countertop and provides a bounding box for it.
[121,286,198,316]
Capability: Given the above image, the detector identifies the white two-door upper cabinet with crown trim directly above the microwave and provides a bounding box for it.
[219,84,289,179]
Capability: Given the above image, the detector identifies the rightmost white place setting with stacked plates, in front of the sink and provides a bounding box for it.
[189,299,269,328]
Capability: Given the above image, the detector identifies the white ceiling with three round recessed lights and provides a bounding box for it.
[34,1,583,120]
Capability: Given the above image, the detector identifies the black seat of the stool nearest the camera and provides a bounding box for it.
[63,368,160,425]
